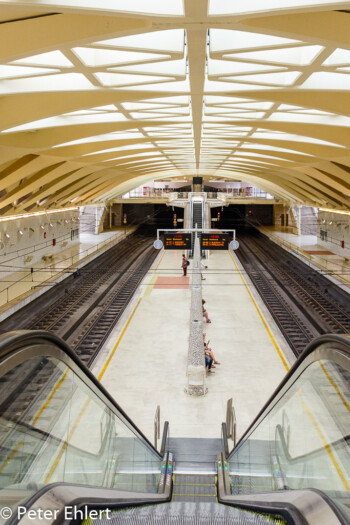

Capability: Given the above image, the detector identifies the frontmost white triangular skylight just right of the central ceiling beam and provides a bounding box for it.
[210,28,299,53]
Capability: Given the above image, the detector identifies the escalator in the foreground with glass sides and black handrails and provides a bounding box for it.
[0,331,350,525]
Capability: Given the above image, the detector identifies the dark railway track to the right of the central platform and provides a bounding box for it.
[237,230,350,356]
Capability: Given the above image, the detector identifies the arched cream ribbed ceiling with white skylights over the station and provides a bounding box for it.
[0,0,350,215]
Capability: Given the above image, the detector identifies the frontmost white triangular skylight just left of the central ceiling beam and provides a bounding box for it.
[99,30,185,53]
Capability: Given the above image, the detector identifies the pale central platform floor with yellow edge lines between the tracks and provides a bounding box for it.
[93,250,295,441]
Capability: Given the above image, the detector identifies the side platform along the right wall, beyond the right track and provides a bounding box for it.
[258,226,350,293]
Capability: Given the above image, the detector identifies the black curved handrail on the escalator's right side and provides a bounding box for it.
[227,334,350,461]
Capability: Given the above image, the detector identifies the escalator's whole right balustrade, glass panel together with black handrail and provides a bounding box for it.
[219,334,350,525]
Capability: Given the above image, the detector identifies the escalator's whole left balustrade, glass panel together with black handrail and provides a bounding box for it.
[0,331,172,524]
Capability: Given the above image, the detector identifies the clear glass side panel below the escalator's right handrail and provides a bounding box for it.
[228,342,350,517]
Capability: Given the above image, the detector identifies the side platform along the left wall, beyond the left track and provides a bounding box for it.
[0,226,136,321]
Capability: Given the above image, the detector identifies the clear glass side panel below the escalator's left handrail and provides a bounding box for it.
[0,343,161,523]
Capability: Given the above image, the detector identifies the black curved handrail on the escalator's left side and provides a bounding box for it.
[0,330,162,459]
